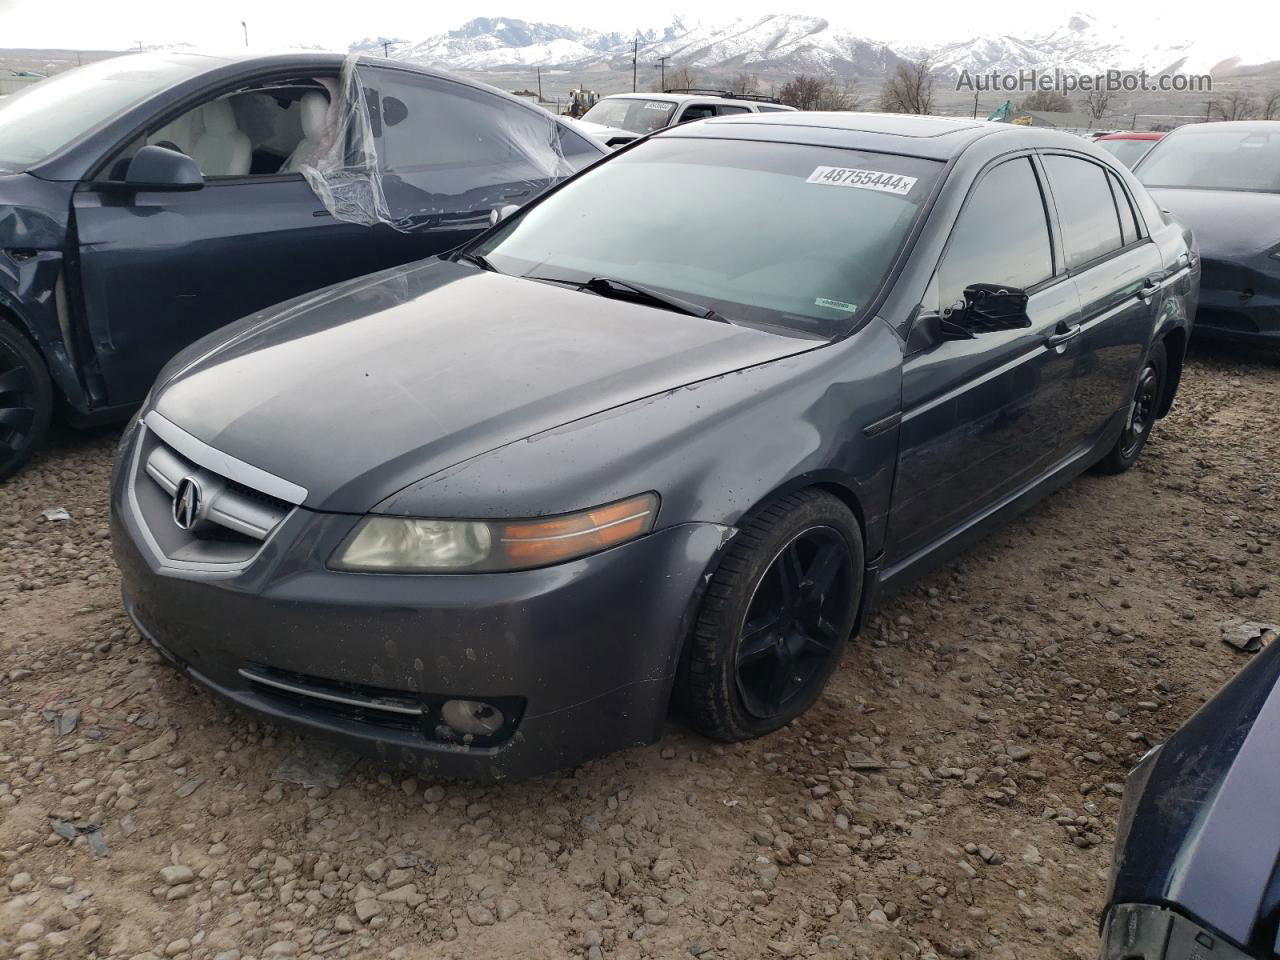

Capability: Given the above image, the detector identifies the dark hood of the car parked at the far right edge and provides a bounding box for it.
[1149,187,1280,260]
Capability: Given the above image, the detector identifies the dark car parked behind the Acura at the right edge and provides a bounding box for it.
[1134,120,1280,347]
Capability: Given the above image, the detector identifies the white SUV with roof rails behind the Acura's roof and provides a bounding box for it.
[575,90,795,147]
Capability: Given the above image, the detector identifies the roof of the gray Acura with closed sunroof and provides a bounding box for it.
[653,111,1088,160]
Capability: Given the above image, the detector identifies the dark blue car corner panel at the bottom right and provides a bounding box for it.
[1110,634,1280,956]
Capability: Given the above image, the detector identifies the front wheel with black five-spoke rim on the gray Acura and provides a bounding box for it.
[677,490,863,741]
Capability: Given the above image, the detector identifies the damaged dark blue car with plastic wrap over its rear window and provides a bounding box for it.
[0,54,604,479]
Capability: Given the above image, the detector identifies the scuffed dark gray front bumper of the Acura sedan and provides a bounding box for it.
[111,427,728,780]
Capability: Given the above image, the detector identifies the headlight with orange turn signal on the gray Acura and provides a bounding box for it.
[329,493,658,573]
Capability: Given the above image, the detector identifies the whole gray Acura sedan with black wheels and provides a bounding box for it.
[111,114,1198,778]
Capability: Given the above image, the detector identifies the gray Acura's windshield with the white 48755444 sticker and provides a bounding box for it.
[477,137,942,338]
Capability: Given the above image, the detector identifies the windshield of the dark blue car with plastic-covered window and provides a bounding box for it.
[0,54,210,173]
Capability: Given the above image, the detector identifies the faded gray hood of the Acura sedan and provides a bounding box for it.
[155,260,822,513]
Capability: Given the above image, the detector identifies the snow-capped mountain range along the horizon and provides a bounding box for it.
[351,13,1280,77]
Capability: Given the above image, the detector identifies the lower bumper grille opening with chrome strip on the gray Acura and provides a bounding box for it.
[239,664,525,749]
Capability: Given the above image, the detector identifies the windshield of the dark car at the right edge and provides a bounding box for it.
[1137,124,1280,193]
